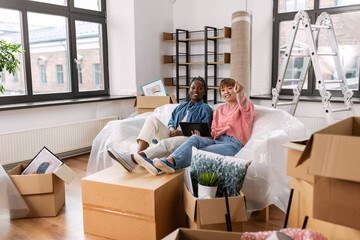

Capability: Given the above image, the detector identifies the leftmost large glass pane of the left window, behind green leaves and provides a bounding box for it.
[0,8,26,97]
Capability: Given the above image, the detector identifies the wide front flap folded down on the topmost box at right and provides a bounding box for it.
[309,133,360,182]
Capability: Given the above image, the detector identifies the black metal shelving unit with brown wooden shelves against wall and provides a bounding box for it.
[162,26,231,104]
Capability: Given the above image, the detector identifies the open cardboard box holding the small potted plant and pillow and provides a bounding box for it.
[184,185,247,232]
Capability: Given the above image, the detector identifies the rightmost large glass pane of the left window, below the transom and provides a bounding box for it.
[75,21,104,91]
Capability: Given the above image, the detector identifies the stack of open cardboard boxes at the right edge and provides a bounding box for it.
[285,117,360,239]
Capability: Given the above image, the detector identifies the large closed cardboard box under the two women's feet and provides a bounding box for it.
[81,165,186,239]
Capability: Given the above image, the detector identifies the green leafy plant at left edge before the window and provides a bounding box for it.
[0,39,25,93]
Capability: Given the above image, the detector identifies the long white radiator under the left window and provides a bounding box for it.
[0,116,117,165]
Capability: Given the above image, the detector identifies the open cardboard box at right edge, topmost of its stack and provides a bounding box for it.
[298,117,360,229]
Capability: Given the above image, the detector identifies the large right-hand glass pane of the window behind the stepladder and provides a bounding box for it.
[319,12,360,90]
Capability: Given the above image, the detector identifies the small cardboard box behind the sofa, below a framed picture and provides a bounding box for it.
[134,94,177,113]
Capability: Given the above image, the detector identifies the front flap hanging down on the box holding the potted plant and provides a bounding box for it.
[197,193,247,225]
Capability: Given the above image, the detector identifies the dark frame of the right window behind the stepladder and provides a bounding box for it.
[271,0,360,97]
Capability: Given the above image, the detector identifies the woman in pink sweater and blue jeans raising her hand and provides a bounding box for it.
[139,78,254,173]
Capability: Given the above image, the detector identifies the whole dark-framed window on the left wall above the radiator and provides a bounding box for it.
[0,0,109,104]
